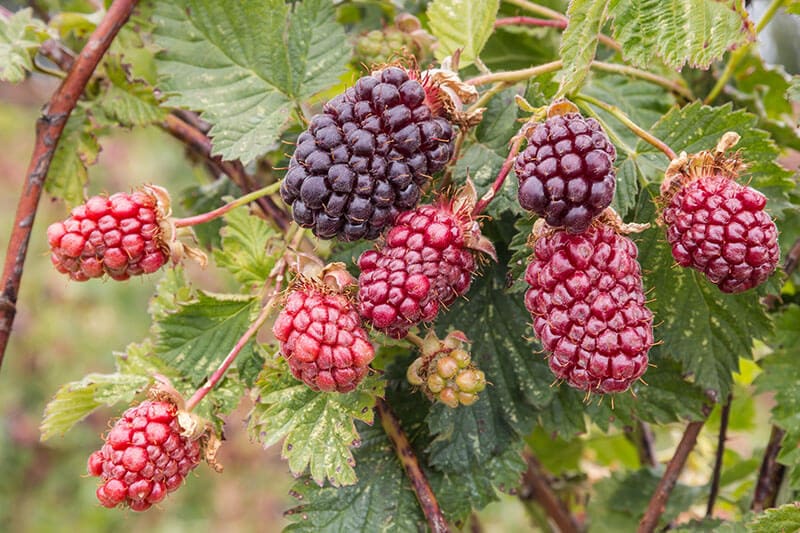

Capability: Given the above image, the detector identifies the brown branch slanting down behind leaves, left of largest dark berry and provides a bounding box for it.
[161,114,289,231]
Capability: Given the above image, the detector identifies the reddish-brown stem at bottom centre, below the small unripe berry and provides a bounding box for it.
[375,398,450,533]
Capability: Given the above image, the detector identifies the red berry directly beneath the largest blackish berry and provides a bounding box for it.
[358,204,475,338]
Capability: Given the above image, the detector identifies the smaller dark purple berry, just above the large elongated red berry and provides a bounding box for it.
[514,113,616,233]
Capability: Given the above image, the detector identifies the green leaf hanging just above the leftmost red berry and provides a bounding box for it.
[45,107,100,206]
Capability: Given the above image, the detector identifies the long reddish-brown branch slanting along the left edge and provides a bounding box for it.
[0,0,137,370]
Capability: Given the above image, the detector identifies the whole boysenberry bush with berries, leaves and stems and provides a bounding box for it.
[0,0,800,532]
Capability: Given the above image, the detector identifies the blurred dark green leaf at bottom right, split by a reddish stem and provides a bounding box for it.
[587,469,704,533]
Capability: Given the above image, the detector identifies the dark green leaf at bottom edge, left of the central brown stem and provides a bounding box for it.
[286,423,425,533]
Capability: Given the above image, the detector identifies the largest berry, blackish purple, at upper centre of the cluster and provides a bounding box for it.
[281,67,453,241]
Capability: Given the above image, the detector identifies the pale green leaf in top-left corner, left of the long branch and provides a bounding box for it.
[0,8,50,83]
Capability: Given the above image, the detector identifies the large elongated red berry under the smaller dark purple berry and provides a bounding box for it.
[525,222,653,393]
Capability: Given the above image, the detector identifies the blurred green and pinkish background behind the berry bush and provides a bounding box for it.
[0,3,800,533]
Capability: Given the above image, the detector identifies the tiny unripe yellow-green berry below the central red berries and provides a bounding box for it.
[406,331,486,409]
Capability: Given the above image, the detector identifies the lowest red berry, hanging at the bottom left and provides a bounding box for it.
[88,401,200,511]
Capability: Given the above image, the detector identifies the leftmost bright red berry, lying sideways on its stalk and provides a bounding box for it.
[47,191,169,281]
